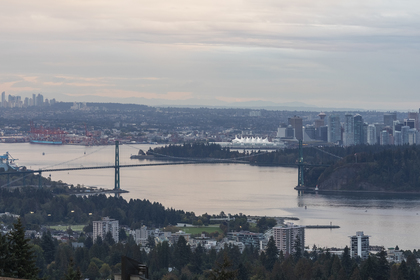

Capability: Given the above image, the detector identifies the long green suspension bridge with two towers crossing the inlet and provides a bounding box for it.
[0,141,340,191]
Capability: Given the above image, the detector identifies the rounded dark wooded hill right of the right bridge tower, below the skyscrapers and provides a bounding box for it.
[316,145,420,192]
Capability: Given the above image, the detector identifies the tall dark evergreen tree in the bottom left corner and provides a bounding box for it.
[8,218,39,279]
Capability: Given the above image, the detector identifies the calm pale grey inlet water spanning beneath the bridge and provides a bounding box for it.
[0,143,420,250]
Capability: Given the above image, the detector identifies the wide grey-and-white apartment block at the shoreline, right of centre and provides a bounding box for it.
[273,223,305,255]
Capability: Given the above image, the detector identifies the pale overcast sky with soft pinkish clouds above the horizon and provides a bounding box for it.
[0,0,420,110]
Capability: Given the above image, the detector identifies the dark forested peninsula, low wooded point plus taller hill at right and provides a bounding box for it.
[147,143,420,193]
